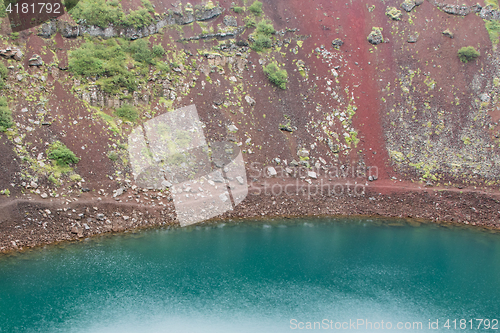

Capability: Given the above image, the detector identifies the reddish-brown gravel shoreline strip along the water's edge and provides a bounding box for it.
[0,179,500,253]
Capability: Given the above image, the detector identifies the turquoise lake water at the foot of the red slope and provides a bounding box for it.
[0,219,500,332]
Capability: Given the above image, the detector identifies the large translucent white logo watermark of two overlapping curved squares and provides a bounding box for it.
[128,105,248,226]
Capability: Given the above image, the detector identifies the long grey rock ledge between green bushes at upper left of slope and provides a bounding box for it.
[38,5,224,40]
